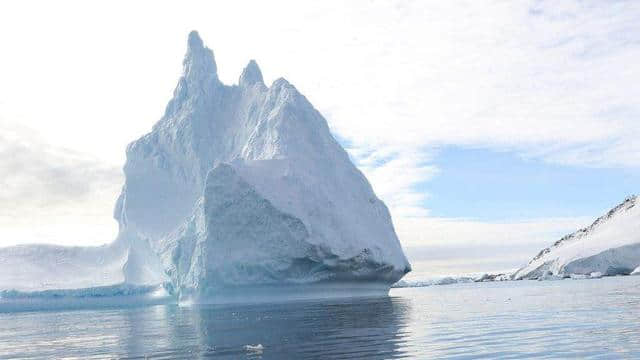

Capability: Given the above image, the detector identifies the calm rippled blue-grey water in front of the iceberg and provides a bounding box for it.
[0,276,640,359]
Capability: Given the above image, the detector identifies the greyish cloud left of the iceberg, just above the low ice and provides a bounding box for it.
[0,122,123,246]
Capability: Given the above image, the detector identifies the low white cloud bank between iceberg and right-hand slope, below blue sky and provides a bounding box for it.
[394,217,593,278]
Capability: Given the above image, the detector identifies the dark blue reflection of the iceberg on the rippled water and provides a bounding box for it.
[0,297,410,359]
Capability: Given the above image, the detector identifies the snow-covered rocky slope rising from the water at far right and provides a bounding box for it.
[514,196,640,279]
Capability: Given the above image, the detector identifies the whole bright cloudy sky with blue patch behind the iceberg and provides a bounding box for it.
[0,1,640,278]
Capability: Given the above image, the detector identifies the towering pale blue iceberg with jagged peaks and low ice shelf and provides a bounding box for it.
[0,32,410,302]
